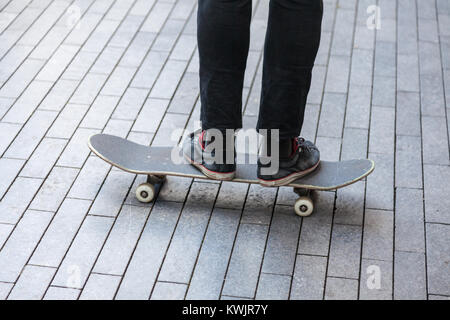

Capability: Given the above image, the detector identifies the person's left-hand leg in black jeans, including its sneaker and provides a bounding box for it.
[183,0,252,180]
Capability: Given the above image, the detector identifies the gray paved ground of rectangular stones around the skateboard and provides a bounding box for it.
[0,0,450,299]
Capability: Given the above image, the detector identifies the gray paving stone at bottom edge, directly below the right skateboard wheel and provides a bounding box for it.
[290,255,327,300]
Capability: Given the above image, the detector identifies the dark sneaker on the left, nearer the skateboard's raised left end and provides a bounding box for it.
[182,130,236,180]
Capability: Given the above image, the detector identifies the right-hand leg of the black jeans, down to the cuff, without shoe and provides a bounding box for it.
[257,0,323,139]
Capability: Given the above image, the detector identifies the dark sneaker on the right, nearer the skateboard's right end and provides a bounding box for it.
[258,137,320,187]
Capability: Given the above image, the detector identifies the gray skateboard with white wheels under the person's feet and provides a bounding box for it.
[88,134,375,217]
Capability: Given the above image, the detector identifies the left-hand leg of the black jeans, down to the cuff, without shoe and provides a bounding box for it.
[197,0,252,130]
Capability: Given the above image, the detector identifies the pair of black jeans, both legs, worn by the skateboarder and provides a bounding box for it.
[197,0,323,138]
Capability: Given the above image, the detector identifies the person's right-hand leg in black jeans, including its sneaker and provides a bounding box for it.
[257,0,323,186]
